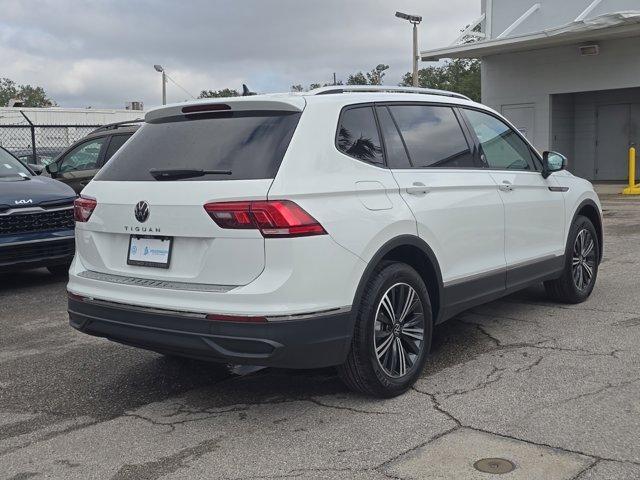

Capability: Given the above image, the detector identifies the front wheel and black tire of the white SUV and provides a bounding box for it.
[544,215,600,303]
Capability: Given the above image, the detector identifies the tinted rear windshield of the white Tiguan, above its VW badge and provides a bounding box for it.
[95,111,301,181]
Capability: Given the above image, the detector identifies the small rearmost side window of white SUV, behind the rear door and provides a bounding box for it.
[336,107,384,165]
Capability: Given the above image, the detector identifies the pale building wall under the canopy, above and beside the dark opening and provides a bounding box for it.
[482,38,640,150]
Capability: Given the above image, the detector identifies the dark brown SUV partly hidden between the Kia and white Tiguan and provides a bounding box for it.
[43,121,139,193]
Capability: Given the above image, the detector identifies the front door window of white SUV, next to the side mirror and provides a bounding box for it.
[465,109,533,170]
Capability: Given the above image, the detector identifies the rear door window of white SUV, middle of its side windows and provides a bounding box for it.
[389,105,476,168]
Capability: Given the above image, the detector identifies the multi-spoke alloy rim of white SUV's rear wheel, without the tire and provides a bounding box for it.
[373,283,425,378]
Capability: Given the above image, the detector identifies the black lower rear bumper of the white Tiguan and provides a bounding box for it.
[69,298,353,368]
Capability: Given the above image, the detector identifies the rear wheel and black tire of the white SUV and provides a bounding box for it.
[338,262,433,398]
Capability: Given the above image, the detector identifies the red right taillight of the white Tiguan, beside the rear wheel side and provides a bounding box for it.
[204,200,327,238]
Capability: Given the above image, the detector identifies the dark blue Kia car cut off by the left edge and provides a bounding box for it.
[0,147,76,275]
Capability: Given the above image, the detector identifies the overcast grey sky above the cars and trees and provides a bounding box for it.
[0,0,480,108]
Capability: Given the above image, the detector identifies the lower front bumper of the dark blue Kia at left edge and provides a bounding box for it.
[0,230,75,272]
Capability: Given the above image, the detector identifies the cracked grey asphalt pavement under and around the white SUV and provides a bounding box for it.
[0,197,640,480]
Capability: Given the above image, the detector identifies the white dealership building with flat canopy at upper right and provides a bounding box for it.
[421,0,640,181]
